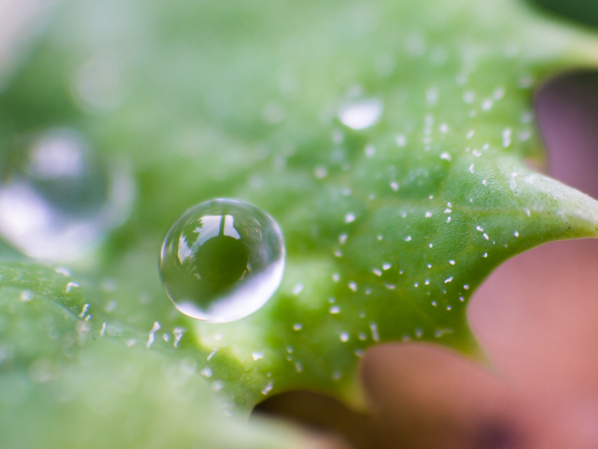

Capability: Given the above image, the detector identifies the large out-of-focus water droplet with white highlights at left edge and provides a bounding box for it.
[0,128,133,261]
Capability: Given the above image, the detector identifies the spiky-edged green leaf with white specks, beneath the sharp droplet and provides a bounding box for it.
[0,0,598,438]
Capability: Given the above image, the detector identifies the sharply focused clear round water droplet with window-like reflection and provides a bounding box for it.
[160,199,285,323]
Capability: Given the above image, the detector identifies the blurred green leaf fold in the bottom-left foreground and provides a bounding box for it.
[0,262,309,449]
